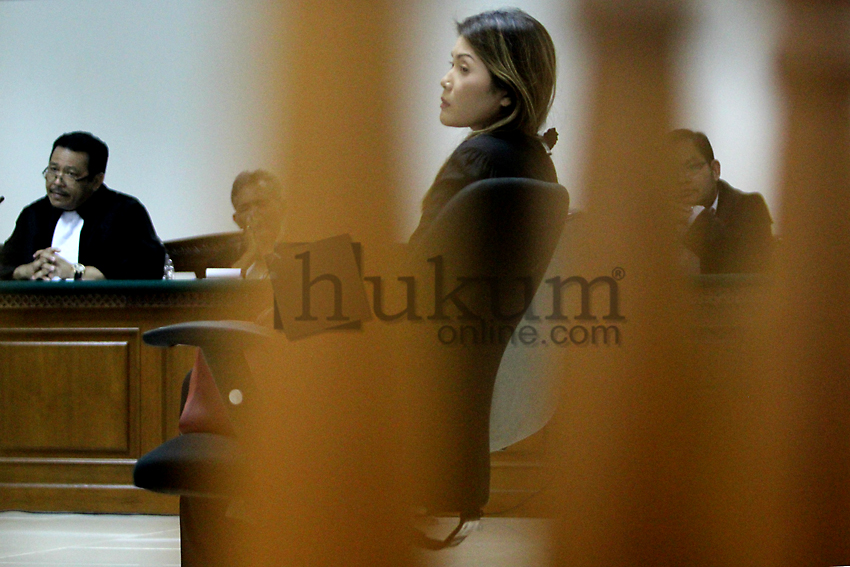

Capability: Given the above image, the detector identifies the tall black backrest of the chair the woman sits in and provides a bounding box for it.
[402,178,569,514]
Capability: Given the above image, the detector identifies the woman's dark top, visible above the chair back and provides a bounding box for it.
[410,130,558,243]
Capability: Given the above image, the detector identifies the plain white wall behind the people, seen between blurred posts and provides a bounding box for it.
[0,0,779,240]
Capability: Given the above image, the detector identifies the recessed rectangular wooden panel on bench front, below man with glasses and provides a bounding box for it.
[0,329,138,455]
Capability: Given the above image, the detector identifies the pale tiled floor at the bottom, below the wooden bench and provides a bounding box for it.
[0,512,548,567]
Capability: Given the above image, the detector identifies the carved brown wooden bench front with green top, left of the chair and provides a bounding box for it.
[0,282,271,513]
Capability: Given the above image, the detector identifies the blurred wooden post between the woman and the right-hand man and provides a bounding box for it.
[554,0,699,566]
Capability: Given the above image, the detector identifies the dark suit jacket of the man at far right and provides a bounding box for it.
[685,180,773,274]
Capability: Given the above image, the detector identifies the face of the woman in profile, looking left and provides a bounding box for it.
[440,36,511,130]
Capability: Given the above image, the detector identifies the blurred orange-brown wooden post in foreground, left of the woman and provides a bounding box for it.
[237,0,409,567]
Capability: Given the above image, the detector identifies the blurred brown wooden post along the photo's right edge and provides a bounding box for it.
[774,1,850,566]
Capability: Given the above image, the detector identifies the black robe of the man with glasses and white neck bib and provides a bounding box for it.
[0,185,165,280]
